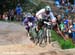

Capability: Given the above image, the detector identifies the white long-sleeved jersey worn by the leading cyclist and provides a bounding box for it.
[36,9,56,20]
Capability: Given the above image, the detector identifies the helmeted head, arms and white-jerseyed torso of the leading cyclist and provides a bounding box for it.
[36,6,56,23]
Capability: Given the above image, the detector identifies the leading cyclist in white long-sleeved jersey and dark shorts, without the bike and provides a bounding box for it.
[36,6,56,29]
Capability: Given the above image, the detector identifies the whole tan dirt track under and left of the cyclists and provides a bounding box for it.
[0,22,75,55]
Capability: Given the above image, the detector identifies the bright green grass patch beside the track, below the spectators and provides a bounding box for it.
[52,31,75,49]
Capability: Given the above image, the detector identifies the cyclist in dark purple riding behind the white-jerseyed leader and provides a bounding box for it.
[23,13,36,32]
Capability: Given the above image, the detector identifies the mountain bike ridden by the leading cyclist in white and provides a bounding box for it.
[39,21,52,47]
